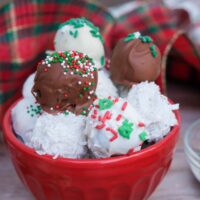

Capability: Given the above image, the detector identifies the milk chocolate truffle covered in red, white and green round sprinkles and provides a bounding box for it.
[32,51,97,115]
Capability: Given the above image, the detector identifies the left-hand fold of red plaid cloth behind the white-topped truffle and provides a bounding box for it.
[0,0,114,122]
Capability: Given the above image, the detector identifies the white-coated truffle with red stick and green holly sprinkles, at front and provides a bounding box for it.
[85,98,148,158]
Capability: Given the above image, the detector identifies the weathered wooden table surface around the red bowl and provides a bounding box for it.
[0,82,200,200]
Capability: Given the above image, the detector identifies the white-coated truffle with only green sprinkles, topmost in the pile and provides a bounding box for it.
[54,18,105,69]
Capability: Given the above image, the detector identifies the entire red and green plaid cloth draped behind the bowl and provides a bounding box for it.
[0,0,200,124]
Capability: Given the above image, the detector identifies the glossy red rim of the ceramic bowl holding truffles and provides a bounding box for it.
[2,98,181,167]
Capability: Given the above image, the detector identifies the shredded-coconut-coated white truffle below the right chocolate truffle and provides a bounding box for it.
[127,81,179,140]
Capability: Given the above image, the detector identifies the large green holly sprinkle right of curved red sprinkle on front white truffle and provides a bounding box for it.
[118,119,133,139]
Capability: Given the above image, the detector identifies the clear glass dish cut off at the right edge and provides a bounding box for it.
[184,119,200,182]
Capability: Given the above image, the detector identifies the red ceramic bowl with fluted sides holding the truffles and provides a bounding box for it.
[3,99,180,200]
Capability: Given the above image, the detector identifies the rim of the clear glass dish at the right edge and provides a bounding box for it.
[184,119,200,161]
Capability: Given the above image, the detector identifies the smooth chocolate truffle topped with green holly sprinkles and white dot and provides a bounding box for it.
[110,32,161,87]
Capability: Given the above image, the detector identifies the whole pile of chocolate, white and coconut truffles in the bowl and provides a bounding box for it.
[11,18,178,159]
